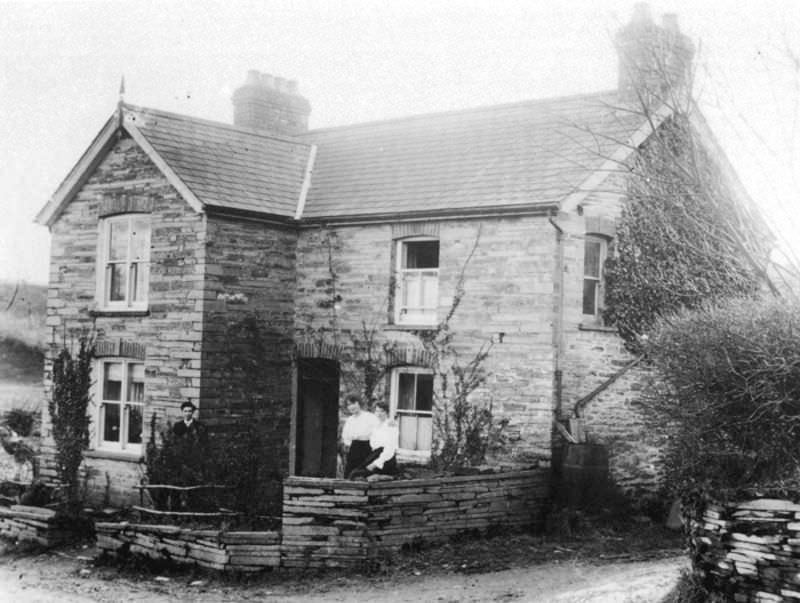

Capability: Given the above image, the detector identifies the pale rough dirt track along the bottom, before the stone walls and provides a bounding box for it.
[0,523,686,603]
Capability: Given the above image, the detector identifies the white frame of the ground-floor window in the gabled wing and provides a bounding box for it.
[91,357,146,457]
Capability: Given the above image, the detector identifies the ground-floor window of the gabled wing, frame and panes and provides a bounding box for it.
[95,359,144,454]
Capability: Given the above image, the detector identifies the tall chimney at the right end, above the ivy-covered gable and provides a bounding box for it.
[615,2,694,106]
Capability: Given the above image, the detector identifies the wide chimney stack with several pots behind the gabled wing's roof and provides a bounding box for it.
[233,70,311,135]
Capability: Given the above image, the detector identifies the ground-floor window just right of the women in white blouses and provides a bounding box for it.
[391,367,433,454]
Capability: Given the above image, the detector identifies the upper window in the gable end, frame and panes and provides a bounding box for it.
[97,214,150,310]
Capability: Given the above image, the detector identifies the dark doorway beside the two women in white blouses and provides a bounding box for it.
[295,358,339,477]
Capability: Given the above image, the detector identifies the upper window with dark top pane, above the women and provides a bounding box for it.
[395,239,439,325]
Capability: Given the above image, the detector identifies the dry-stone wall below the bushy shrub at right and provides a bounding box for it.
[689,496,800,603]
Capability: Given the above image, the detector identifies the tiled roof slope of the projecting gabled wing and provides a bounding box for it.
[124,105,310,218]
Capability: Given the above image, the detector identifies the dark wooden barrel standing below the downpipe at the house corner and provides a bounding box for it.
[561,444,610,509]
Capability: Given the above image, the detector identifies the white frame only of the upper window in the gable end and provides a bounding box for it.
[95,212,152,312]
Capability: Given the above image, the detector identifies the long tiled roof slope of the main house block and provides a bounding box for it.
[302,92,643,218]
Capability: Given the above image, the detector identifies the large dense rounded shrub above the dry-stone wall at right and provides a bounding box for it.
[647,299,800,493]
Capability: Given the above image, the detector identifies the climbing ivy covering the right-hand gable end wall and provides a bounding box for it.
[604,113,769,353]
